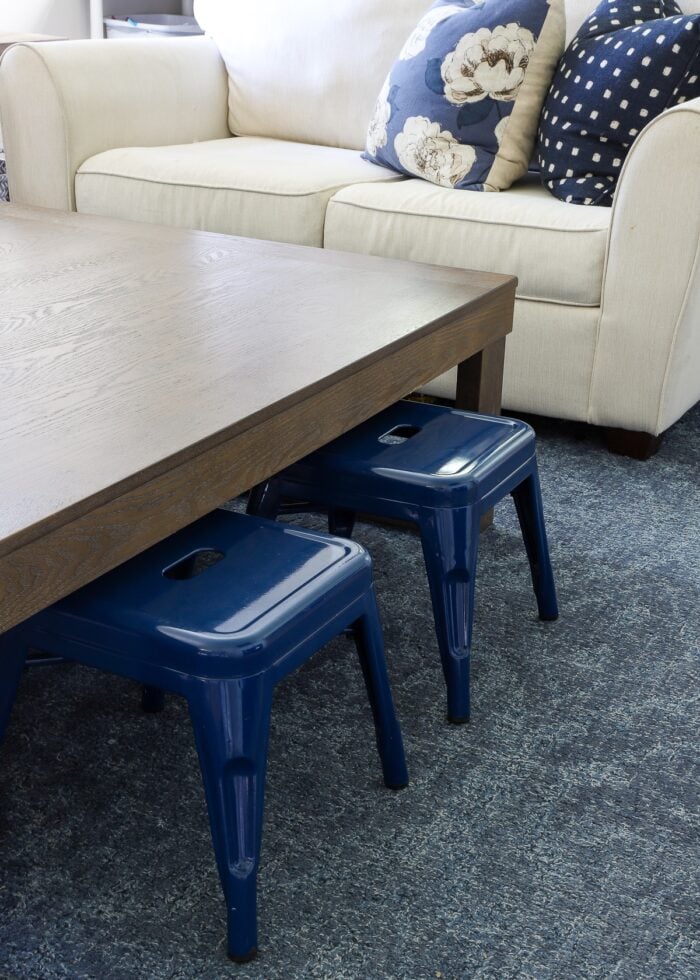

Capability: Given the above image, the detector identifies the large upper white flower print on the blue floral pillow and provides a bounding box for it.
[440,24,535,105]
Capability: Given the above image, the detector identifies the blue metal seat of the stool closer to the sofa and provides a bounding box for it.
[284,401,535,512]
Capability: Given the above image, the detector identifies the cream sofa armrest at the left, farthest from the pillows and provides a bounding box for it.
[0,37,231,211]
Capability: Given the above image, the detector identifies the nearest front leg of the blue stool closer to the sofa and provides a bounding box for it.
[419,507,479,724]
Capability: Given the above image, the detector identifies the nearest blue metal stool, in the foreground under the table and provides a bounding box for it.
[0,510,408,961]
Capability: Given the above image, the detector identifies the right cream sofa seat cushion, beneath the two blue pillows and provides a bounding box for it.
[324,177,610,306]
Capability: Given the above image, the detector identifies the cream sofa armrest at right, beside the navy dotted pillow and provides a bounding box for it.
[589,99,700,435]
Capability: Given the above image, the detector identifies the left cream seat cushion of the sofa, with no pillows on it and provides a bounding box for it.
[75,137,400,246]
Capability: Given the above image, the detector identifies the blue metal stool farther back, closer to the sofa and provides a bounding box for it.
[248,401,559,723]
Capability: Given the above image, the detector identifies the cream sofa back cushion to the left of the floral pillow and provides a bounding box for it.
[194,0,430,150]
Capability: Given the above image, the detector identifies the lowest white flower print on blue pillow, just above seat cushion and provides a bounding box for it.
[394,116,476,187]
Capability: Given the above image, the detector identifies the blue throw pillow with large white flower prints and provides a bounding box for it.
[364,0,564,191]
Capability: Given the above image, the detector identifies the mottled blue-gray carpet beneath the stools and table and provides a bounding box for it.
[0,409,700,980]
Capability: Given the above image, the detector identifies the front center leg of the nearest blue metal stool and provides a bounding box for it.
[187,675,272,963]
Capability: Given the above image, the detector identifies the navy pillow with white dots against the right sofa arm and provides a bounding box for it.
[537,0,700,207]
